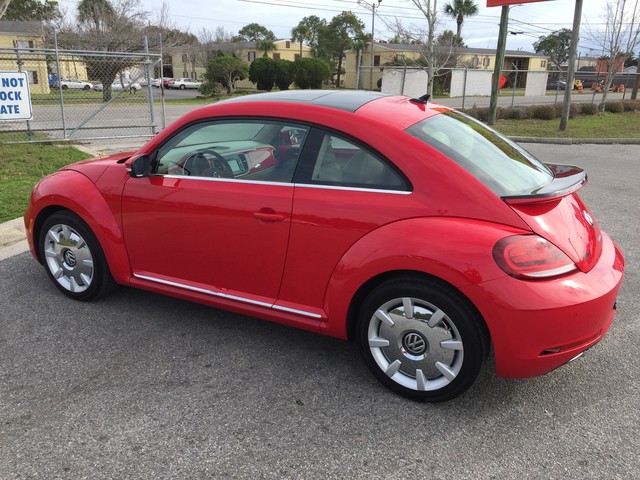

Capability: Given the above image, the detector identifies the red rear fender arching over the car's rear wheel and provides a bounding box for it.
[322,217,525,338]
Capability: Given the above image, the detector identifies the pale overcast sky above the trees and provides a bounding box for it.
[60,0,604,55]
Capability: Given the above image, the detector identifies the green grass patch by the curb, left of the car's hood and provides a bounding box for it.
[0,138,90,222]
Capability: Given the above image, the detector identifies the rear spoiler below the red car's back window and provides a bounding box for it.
[502,164,587,205]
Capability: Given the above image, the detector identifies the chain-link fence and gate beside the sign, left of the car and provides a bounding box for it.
[0,36,164,143]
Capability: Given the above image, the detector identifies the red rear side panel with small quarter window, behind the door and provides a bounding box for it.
[276,128,412,315]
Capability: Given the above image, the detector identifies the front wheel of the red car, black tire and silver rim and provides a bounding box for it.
[38,211,116,300]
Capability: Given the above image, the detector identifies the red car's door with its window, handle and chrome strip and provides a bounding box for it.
[122,120,308,305]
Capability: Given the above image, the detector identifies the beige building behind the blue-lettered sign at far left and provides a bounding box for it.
[0,20,49,93]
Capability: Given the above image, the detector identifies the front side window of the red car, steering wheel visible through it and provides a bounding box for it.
[153,120,309,182]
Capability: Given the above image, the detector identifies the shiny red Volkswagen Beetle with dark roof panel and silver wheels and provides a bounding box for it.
[25,91,624,401]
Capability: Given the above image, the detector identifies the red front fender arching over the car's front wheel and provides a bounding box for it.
[24,170,131,283]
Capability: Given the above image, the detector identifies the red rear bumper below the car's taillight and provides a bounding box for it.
[463,234,624,378]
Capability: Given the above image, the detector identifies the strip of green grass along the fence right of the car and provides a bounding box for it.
[493,112,640,139]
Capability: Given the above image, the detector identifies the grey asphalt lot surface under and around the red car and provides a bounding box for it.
[0,144,640,479]
